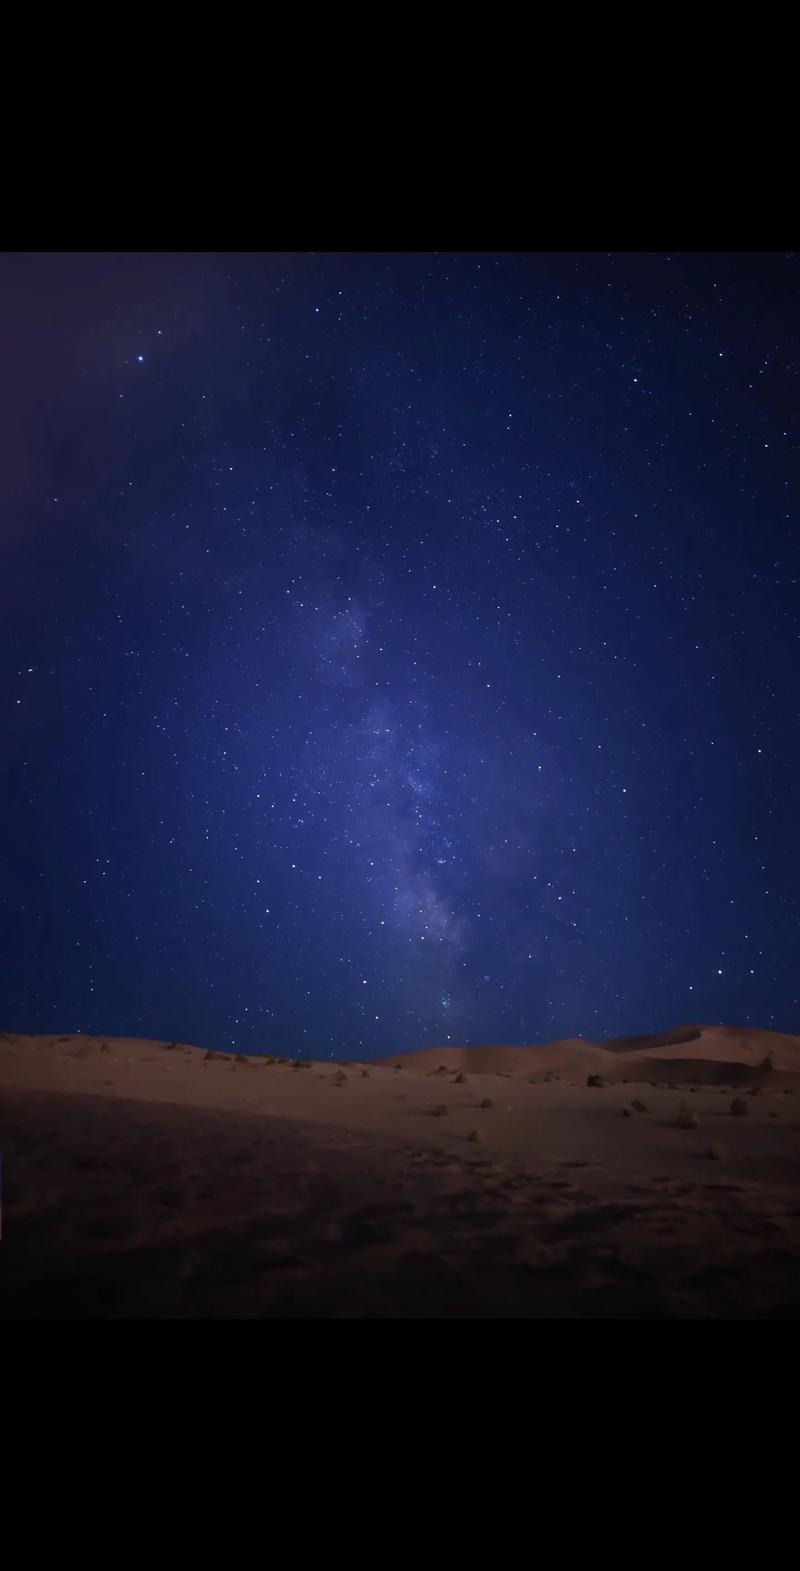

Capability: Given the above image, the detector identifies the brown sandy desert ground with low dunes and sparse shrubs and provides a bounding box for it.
[0,1027,800,1318]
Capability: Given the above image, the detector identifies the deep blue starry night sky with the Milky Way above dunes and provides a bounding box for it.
[0,251,800,1057]
